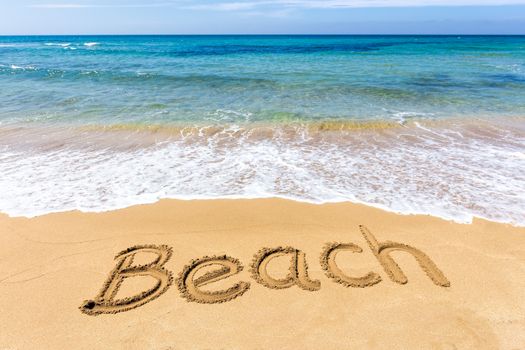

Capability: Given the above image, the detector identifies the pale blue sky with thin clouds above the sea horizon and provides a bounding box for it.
[0,0,525,35]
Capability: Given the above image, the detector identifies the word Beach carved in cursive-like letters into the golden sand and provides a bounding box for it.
[80,226,450,315]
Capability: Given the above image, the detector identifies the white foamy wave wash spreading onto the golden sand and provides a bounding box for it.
[0,119,525,225]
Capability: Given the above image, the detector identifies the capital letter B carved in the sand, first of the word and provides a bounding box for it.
[80,245,172,315]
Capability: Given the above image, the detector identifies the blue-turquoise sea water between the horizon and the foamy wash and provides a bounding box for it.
[0,35,525,123]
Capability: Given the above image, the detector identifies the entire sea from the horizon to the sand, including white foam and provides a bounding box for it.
[0,36,525,225]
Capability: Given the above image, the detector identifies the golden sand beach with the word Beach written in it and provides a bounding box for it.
[0,199,525,350]
